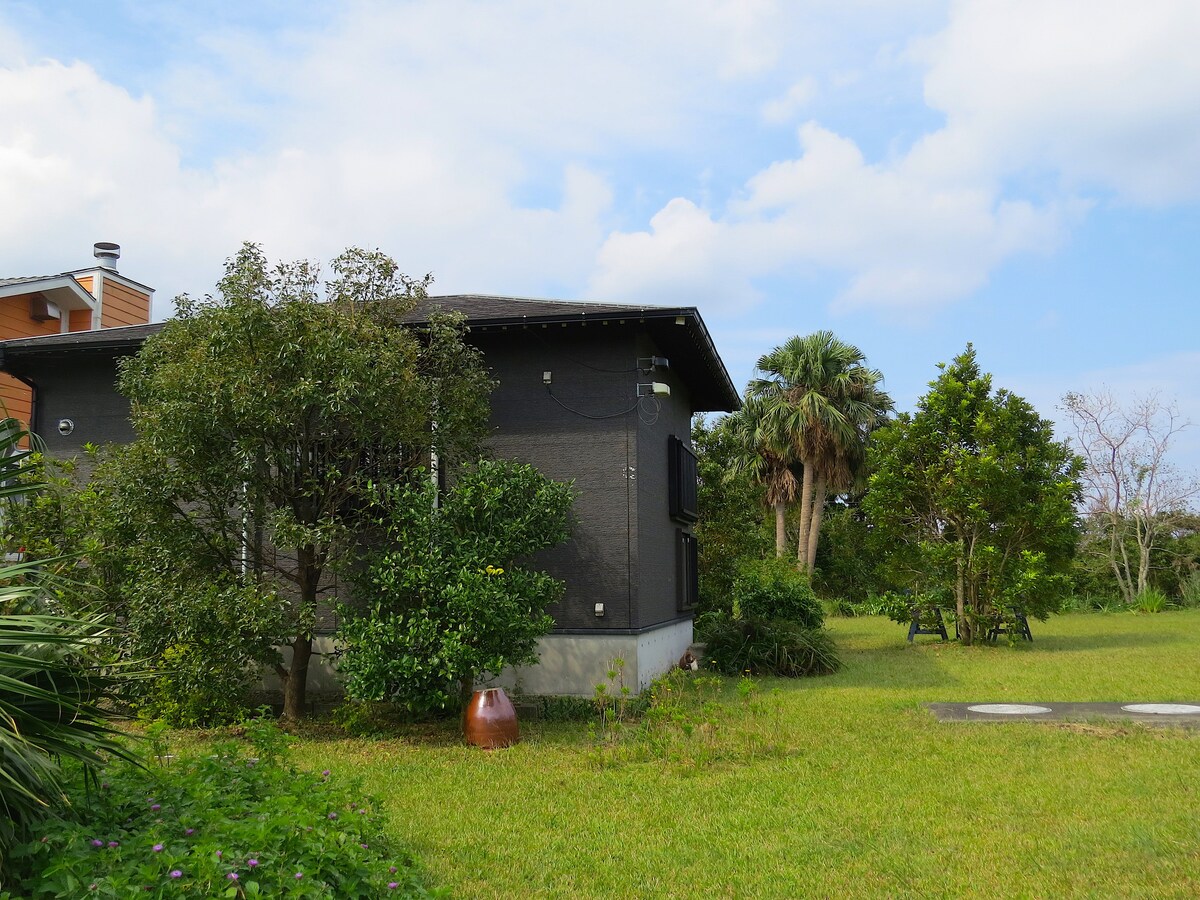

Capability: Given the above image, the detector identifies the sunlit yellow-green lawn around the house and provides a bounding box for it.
[295,611,1200,898]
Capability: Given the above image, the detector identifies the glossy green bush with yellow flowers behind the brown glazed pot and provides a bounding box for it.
[337,461,574,713]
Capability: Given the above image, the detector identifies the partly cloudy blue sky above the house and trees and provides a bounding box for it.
[0,0,1200,470]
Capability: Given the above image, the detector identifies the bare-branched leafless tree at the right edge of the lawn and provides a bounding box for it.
[1063,389,1200,602]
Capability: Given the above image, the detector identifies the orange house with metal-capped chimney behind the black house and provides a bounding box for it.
[0,242,154,431]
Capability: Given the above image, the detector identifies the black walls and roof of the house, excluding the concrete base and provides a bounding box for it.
[0,298,737,634]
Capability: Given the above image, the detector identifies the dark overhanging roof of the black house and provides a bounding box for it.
[0,294,740,410]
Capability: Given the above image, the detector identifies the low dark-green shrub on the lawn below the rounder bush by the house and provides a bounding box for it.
[704,618,841,678]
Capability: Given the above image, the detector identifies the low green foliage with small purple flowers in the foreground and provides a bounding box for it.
[3,722,428,898]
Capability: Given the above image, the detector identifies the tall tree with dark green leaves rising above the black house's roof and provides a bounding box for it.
[110,244,492,718]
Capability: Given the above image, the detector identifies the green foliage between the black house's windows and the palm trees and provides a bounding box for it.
[691,416,770,610]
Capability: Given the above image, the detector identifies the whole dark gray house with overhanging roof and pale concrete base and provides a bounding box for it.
[0,295,738,695]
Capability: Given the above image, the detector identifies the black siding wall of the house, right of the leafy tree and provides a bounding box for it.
[472,324,691,631]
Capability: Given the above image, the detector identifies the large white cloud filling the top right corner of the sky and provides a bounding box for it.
[912,0,1200,204]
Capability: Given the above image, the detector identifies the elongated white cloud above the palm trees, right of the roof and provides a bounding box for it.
[594,122,1072,310]
